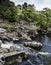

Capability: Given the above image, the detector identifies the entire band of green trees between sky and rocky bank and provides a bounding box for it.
[0,0,51,29]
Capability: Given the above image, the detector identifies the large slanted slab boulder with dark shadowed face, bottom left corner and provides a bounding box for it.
[0,51,28,65]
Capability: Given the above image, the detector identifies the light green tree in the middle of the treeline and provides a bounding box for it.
[22,6,35,22]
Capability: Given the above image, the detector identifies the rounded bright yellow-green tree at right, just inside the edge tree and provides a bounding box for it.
[35,13,46,28]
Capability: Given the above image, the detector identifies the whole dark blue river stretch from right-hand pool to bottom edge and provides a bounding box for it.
[20,35,51,65]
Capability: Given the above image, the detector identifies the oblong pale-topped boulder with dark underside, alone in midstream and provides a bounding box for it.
[24,42,42,50]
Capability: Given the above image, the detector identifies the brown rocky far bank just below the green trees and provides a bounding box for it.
[0,21,38,41]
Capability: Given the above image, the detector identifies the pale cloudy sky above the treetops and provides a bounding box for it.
[11,0,51,10]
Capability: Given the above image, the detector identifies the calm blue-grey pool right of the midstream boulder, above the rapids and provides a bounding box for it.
[36,35,51,53]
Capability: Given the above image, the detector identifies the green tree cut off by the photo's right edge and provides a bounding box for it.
[42,8,51,29]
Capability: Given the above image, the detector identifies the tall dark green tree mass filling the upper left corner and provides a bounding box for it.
[0,0,17,21]
